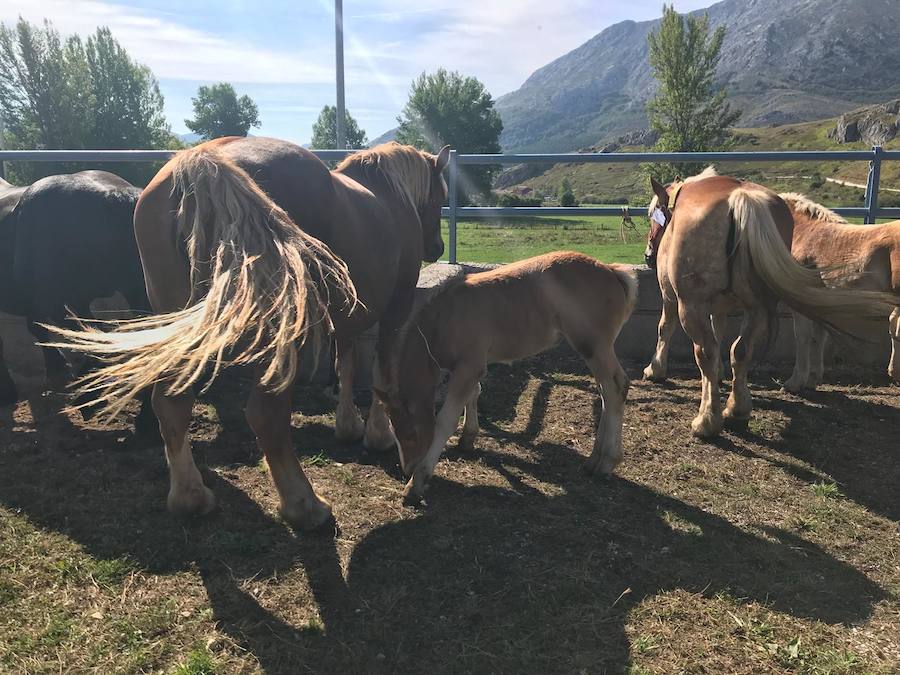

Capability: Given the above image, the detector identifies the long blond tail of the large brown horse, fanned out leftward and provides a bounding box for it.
[51,146,358,419]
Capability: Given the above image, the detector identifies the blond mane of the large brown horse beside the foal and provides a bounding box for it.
[335,141,443,209]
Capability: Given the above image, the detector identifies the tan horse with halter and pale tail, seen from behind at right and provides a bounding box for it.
[644,168,897,437]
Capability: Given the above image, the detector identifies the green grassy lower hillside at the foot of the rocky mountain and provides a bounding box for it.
[510,112,900,206]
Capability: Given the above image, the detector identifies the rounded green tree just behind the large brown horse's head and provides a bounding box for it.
[397,68,503,202]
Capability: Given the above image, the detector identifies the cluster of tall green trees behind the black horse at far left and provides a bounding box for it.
[0,19,177,184]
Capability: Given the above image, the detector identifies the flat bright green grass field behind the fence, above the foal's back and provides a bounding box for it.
[444,216,647,264]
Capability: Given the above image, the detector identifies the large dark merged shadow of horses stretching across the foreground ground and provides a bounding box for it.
[0,412,885,673]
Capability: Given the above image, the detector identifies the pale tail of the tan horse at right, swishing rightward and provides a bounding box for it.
[728,186,898,337]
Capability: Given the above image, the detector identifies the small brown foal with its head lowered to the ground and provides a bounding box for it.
[376,252,637,502]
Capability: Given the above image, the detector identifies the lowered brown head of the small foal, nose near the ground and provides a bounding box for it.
[374,320,440,475]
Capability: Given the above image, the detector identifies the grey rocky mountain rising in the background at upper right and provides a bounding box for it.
[497,0,900,152]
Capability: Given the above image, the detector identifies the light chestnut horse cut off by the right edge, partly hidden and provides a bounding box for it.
[780,193,900,392]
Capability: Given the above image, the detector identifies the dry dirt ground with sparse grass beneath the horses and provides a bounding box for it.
[0,350,900,673]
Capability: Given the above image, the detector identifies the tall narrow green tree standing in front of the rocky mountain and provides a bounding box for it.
[647,5,740,178]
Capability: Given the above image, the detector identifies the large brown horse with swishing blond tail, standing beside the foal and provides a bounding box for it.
[47,138,448,528]
